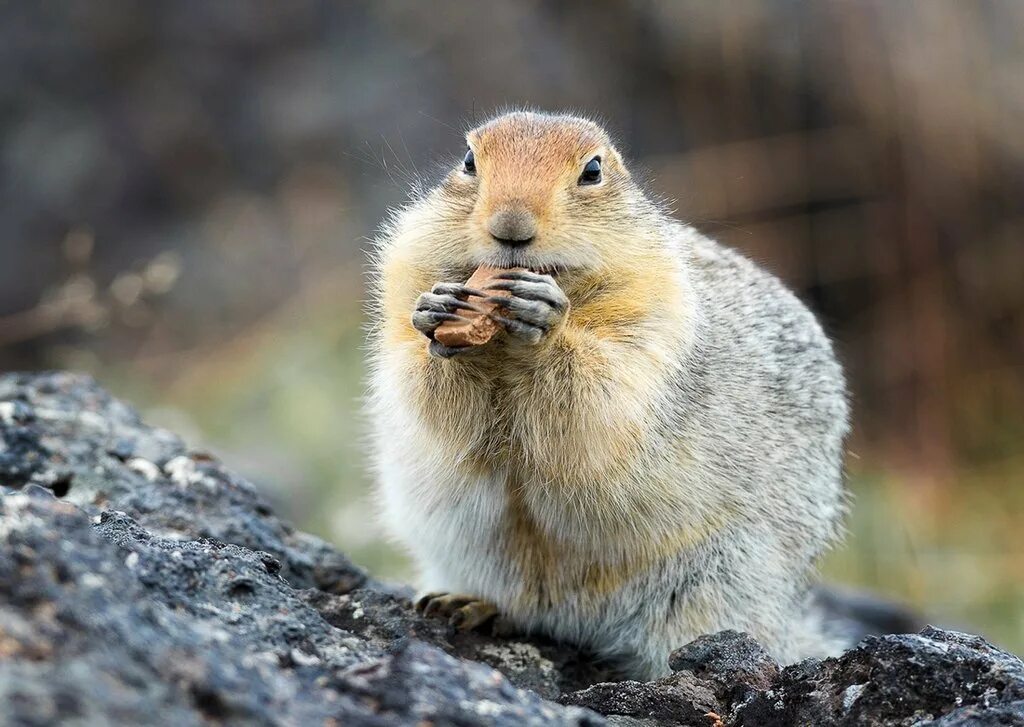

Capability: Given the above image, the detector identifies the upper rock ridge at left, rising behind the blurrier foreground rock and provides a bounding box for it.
[0,373,367,593]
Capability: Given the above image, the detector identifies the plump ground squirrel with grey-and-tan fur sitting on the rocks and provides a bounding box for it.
[369,112,848,678]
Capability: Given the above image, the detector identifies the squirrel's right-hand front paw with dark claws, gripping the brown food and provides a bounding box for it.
[484,270,569,345]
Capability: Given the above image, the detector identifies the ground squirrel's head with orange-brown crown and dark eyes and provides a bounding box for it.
[441,112,647,272]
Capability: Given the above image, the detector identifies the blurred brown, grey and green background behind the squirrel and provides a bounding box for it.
[0,0,1024,653]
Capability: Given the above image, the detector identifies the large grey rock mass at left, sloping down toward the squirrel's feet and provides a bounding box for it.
[0,374,603,725]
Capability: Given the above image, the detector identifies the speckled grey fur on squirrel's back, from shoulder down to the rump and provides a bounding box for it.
[651,227,850,661]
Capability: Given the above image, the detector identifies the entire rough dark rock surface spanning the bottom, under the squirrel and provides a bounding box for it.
[0,374,1024,727]
